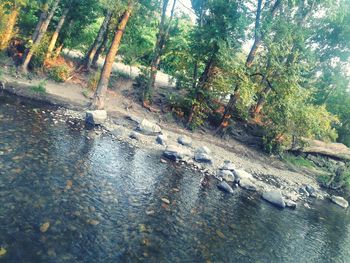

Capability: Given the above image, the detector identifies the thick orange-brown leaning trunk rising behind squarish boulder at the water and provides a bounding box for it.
[92,1,133,109]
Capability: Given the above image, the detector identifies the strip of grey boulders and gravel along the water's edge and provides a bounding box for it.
[1,81,348,209]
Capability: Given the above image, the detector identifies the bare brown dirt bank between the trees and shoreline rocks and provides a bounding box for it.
[0,53,328,196]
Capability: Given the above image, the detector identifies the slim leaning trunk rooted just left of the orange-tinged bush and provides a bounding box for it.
[22,0,60,73]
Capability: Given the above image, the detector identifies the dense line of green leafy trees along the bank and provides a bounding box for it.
[0,0,350,151]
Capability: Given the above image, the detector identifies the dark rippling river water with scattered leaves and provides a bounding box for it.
[0,95,350,263]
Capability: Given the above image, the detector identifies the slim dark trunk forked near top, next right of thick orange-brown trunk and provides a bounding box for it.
[143,0,176,104]
